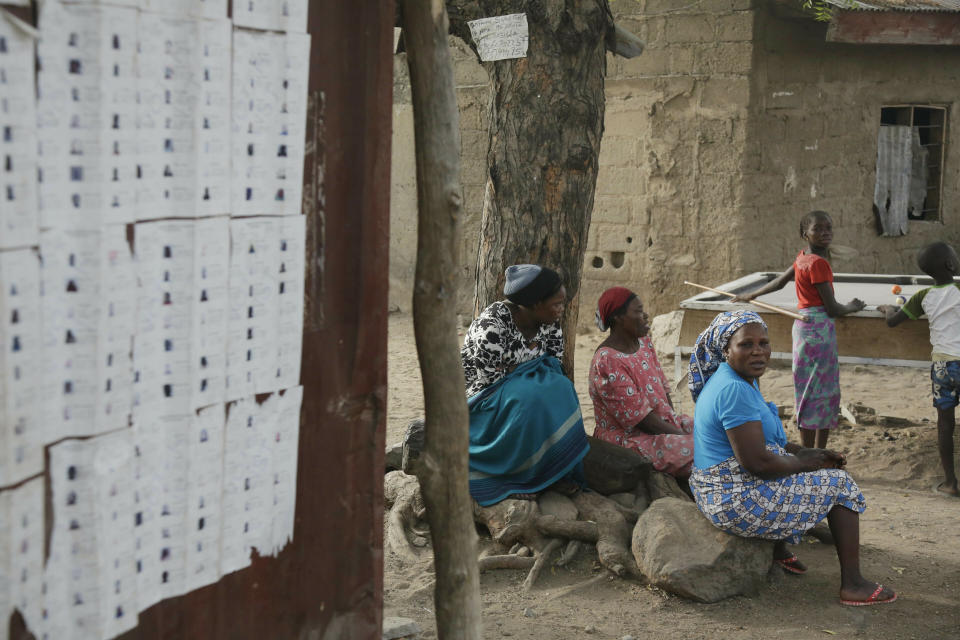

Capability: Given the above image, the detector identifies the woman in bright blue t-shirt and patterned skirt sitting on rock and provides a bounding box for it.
[690,311,897,606]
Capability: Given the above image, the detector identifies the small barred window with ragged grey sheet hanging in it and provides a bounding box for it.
[874,105,947,235]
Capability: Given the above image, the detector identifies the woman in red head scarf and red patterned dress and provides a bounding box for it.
[589,287,693,478]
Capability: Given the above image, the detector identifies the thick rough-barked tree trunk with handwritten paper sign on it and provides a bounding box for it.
[447,0,613,374]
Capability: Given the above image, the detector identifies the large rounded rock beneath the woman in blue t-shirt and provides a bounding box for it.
[632,498,773,602]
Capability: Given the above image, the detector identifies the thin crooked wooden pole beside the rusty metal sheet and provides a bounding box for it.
[401,0,482,640]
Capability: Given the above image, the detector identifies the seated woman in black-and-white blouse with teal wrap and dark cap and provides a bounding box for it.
[460,264,589,506]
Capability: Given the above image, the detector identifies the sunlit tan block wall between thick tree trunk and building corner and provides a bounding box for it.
[580,0,754,320]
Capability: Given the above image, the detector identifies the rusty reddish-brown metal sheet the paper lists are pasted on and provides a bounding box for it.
[4,0,394,640]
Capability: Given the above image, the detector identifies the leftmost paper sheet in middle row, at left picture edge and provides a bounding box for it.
[0,249,46,486]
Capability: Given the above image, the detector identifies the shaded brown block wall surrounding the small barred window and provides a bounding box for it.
[748,3,960,273]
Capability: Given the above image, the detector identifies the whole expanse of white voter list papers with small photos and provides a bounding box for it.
[0,0,310,640]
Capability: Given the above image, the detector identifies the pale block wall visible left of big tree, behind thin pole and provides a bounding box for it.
[390,37,489,323]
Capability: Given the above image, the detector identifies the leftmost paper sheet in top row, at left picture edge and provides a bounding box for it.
[0,12,38,249]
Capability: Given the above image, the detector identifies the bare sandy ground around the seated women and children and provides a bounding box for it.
[384,314,960,640]
